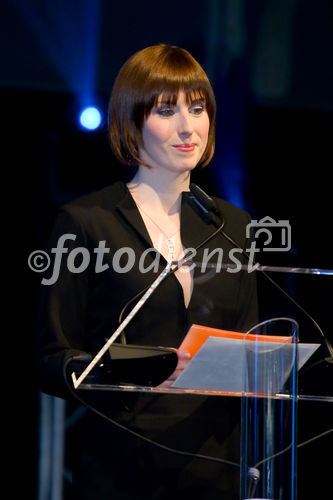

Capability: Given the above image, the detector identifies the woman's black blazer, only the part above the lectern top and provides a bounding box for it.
[35,182,257,396]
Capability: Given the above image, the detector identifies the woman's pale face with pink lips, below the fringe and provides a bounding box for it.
[139,92,209,173]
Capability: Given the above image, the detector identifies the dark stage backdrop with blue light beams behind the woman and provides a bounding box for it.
[0,0,333,500]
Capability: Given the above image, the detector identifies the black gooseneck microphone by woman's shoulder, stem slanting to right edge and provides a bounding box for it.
[190,183,333,363]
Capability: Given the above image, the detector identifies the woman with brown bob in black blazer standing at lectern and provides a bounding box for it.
[35,45,257,500]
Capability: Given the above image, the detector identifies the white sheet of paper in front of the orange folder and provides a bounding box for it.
[172,337,320,392]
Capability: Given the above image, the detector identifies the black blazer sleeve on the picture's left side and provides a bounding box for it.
[33,210,90,397]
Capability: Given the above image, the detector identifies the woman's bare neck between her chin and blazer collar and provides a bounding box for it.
[127,166,190,215]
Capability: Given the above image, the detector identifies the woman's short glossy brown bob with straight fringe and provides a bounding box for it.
[109,44,216,167]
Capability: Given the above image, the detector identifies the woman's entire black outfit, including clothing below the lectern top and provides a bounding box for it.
[34,182,257,500]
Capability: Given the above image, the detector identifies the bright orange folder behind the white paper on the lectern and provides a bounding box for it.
[179,325,292,357]
